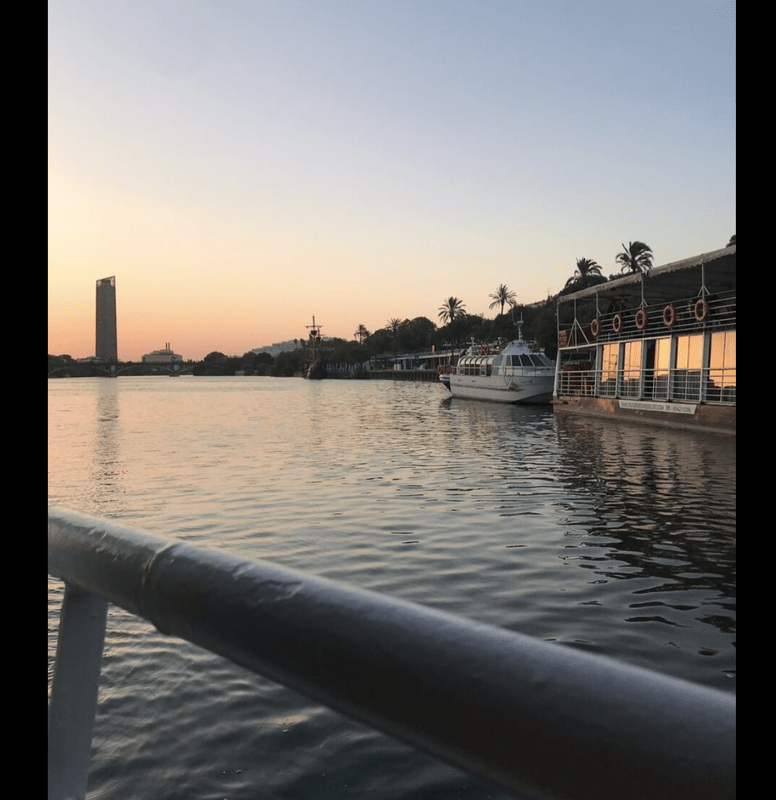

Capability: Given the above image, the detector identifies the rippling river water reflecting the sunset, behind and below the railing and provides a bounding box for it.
[48,377,736,800]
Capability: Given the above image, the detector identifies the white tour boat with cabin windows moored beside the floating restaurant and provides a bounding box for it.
[439,321,555,403]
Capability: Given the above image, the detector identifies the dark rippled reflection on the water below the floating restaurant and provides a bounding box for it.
[556,415,736,648]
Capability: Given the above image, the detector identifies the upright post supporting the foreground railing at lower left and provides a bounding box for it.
[48,584,108,800]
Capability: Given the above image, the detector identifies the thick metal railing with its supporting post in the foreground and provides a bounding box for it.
[48,508,736,800]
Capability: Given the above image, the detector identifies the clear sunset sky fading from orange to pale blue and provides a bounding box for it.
[48,0,736,360]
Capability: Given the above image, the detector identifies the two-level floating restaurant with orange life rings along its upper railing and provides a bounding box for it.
[553,245,736,433]
